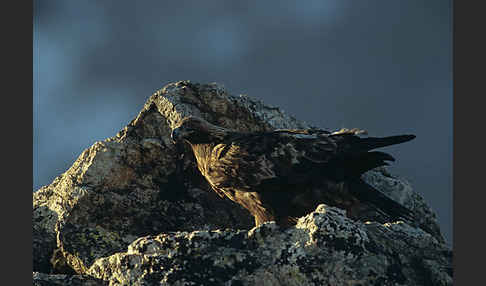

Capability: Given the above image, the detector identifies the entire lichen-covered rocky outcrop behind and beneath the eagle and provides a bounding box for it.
[33,81,451,285]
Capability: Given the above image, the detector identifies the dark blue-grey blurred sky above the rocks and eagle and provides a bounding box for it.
[33,0,452,245]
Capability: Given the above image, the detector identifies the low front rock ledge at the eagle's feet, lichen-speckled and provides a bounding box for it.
[88,205,452,285]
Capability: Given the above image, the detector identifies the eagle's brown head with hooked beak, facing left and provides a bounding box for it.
[170,116,228,145]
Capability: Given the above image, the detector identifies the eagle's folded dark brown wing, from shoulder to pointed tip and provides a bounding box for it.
[207,129,415,191]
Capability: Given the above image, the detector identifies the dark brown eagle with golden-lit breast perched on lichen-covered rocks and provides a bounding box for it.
[171,116,415,227]
